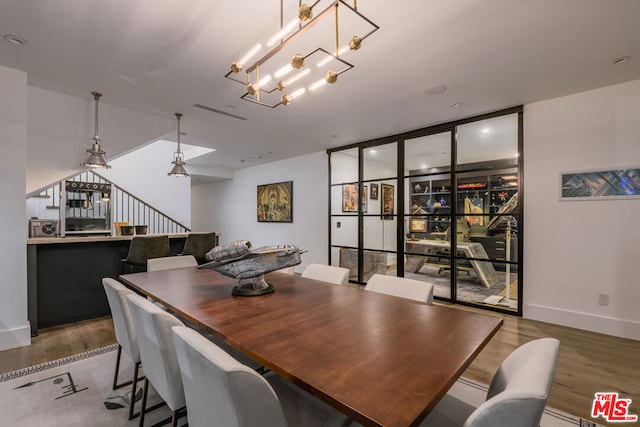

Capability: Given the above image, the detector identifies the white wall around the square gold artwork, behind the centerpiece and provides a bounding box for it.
[191,152,328,271]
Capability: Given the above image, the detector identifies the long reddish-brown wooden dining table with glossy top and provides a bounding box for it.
[120,268,502,427]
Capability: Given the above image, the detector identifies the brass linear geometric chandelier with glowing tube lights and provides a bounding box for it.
[225,0,379,108]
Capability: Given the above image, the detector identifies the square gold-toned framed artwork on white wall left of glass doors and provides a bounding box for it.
[257,181,293,222]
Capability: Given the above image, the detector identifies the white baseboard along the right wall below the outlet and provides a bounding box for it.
[522,304,640,341]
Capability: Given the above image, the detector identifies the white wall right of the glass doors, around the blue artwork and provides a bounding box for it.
[523,80,640,340]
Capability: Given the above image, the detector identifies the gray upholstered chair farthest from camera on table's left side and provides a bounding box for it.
[102,277,142,420]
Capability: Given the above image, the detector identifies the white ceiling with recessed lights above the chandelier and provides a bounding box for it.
[0,0,640,182]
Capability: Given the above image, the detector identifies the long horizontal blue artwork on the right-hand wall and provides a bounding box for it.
[560,168,640,200]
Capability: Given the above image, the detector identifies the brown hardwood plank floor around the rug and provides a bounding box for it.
[0,305,640,425]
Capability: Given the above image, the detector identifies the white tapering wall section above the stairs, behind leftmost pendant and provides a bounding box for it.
[27,86,175,193]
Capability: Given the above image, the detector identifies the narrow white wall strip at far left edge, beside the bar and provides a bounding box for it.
[0,67,31,350]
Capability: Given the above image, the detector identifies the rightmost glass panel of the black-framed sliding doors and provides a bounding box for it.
[456,114,519,310]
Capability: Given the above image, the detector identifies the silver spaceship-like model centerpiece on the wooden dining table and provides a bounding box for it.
[198,240,301,296]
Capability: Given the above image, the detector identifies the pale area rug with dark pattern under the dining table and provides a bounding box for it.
[0,345,597,427]
